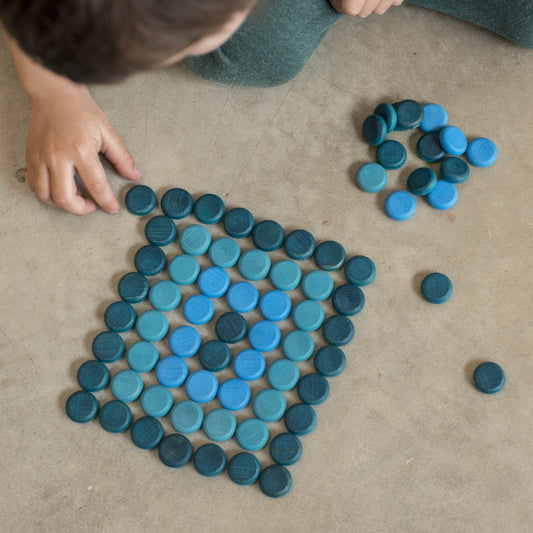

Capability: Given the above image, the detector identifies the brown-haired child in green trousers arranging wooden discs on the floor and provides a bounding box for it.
[0,0,533,215]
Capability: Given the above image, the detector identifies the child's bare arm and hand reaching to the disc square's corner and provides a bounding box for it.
[7,38,140,215]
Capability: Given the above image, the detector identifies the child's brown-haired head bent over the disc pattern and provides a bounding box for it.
[0,0,256,83]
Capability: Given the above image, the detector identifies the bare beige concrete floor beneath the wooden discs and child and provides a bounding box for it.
[0,7,533,533]
